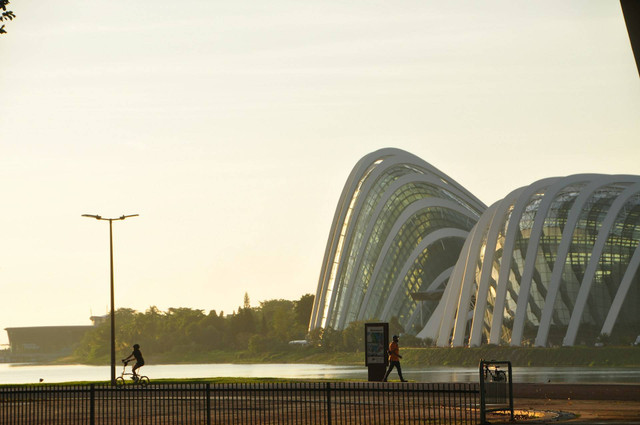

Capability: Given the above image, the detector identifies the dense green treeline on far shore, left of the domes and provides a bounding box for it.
[74,294,314,363]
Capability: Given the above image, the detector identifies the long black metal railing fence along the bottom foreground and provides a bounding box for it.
[0,382,480,425]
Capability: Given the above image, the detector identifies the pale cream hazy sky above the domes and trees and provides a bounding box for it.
[0,0,640,344]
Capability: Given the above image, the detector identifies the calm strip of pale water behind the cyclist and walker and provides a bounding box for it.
[0,363,640,384]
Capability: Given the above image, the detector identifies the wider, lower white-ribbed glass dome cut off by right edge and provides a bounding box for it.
[418,174,640,346]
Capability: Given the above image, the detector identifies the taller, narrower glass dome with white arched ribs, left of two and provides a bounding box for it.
[310,149,486,333]
